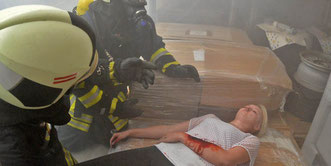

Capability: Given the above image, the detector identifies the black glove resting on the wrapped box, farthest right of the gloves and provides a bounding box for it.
[165,65,200,82]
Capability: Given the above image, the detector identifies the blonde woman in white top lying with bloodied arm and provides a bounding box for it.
[78,105,268,166]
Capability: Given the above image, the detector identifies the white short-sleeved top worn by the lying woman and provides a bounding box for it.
[155,114,260,166]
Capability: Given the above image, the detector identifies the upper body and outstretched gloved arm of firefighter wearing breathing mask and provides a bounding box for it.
[76,0,200,82]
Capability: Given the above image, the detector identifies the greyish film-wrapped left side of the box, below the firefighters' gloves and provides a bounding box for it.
[130,72,202,120]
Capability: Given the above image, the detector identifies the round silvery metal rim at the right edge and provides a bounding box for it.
[294,50,331,93]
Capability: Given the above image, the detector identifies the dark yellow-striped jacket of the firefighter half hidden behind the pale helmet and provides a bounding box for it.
[67,59,128,135]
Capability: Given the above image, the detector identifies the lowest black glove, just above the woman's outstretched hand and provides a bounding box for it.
[114,99,144,119]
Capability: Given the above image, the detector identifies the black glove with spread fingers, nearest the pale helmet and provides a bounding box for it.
[115,57,156,89]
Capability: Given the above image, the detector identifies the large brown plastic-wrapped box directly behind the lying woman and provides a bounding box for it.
[132,41,292,114]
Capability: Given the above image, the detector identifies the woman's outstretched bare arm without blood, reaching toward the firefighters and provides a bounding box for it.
[110,121,190,145]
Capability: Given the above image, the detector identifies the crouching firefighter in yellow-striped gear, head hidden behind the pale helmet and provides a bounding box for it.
[57,57,155,152]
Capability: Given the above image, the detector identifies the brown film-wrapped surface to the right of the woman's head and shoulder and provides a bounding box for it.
[255,112,304,166]
